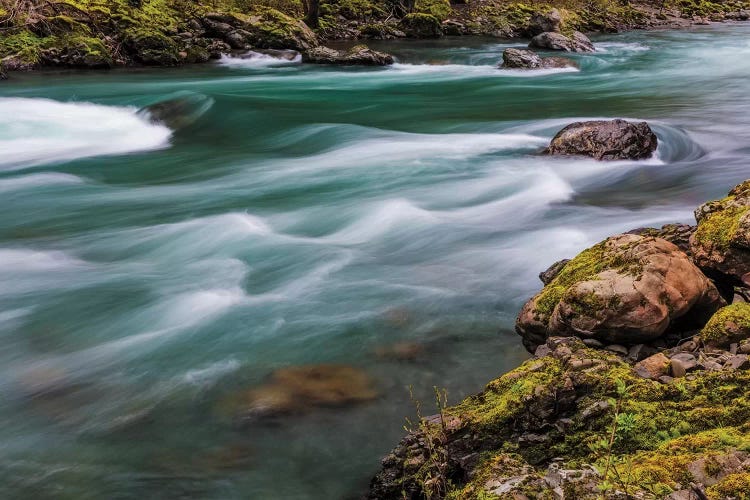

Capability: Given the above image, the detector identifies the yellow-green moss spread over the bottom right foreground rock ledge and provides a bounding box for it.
[418,341,750,499]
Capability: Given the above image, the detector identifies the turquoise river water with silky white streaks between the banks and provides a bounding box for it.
[0,25,750,499]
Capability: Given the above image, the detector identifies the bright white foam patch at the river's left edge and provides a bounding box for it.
[0,97,172,170]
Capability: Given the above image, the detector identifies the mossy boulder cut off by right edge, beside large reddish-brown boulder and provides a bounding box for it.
[690,181,750,288]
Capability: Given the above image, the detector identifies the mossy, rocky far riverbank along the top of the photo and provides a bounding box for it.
[0,0,750,75]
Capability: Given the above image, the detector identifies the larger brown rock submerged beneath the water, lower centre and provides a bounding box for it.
[222,365,378,422]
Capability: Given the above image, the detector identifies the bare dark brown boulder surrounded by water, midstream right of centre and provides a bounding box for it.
[544,120,657,160]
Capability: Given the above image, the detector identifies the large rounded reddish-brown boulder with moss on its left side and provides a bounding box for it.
[516,234,724,352]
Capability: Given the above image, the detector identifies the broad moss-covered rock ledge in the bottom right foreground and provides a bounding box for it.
[368,338,750,500]
